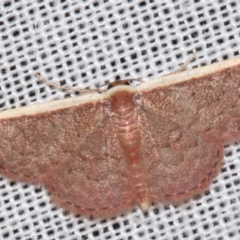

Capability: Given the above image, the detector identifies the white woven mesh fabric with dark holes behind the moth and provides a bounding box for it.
[0,0,240,240]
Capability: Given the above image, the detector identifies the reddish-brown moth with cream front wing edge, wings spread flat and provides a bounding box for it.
[0,57,240,217]
